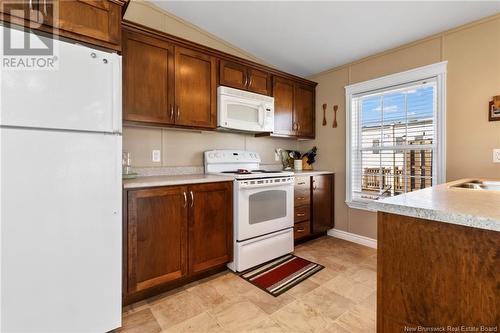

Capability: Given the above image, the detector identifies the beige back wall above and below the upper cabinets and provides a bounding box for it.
[123,1,297,167]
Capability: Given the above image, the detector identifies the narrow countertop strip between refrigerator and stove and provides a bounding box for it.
[123,174,234,189]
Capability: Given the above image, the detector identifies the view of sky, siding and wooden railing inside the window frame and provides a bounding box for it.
[353,80,436,199]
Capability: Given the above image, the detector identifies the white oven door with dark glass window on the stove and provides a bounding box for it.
[234,177,293,241]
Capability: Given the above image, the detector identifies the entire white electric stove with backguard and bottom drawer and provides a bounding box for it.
[204,150,294,272]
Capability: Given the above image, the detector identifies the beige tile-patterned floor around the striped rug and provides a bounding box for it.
[116,237,377,333]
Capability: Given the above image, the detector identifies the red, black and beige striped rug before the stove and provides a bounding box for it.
[240,254,325,297]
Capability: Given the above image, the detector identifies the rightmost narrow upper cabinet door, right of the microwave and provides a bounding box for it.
[294,84,315,138]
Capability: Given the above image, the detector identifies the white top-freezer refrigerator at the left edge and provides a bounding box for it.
[0,27,122,332]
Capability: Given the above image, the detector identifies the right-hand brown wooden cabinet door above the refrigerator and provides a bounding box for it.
[56,0,121,44]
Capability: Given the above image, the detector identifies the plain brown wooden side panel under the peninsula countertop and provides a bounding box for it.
[377,212,500,333]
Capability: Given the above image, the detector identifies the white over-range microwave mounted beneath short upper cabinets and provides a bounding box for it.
[217,86,274,132]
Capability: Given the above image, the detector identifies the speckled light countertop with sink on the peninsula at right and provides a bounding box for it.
[369,179,500,231]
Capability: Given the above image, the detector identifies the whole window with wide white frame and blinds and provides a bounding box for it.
[346,62,446,209]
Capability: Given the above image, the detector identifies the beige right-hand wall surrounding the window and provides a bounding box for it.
[299,15,500,238]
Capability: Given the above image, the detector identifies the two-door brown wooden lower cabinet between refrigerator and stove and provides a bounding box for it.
[123,182,233,304]
